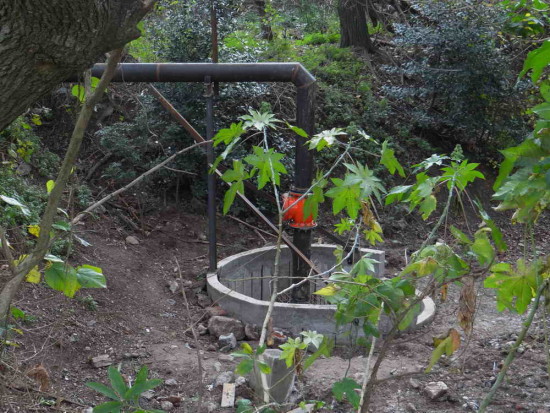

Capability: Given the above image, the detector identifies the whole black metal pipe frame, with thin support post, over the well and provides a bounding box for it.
[73,62,316,296]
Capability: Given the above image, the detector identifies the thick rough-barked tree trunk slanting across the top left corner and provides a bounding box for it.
[0,0,153,130]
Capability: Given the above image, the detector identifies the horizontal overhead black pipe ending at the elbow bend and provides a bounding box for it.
[67,62,315,88]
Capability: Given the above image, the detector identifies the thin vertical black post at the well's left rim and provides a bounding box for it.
[204,76,218,271]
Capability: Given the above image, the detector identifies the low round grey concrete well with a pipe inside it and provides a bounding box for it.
[207,244,435,341]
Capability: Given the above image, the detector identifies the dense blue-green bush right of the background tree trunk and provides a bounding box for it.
[383,2,526,152]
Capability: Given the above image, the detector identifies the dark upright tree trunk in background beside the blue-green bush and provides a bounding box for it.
[338,0,376,53]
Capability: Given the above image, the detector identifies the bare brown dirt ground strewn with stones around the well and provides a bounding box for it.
[0,193,550,413]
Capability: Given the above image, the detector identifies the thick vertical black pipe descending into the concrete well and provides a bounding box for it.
[292,83,315,303]
